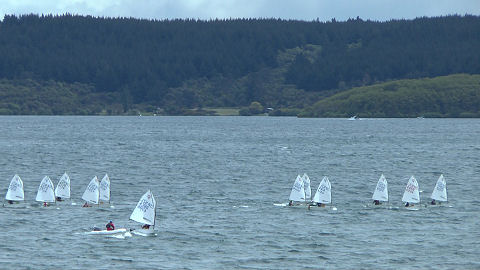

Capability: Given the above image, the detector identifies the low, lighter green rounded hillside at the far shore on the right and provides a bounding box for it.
[301,74,480,117]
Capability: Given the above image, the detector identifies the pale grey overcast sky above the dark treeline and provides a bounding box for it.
[0,0,480,21]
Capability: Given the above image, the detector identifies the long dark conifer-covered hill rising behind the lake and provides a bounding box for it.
[0,15,480,113]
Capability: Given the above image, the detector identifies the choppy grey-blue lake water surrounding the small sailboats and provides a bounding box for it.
[0,117,480,269]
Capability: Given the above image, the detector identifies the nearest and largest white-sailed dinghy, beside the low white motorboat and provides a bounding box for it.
[130,190,157,236]
